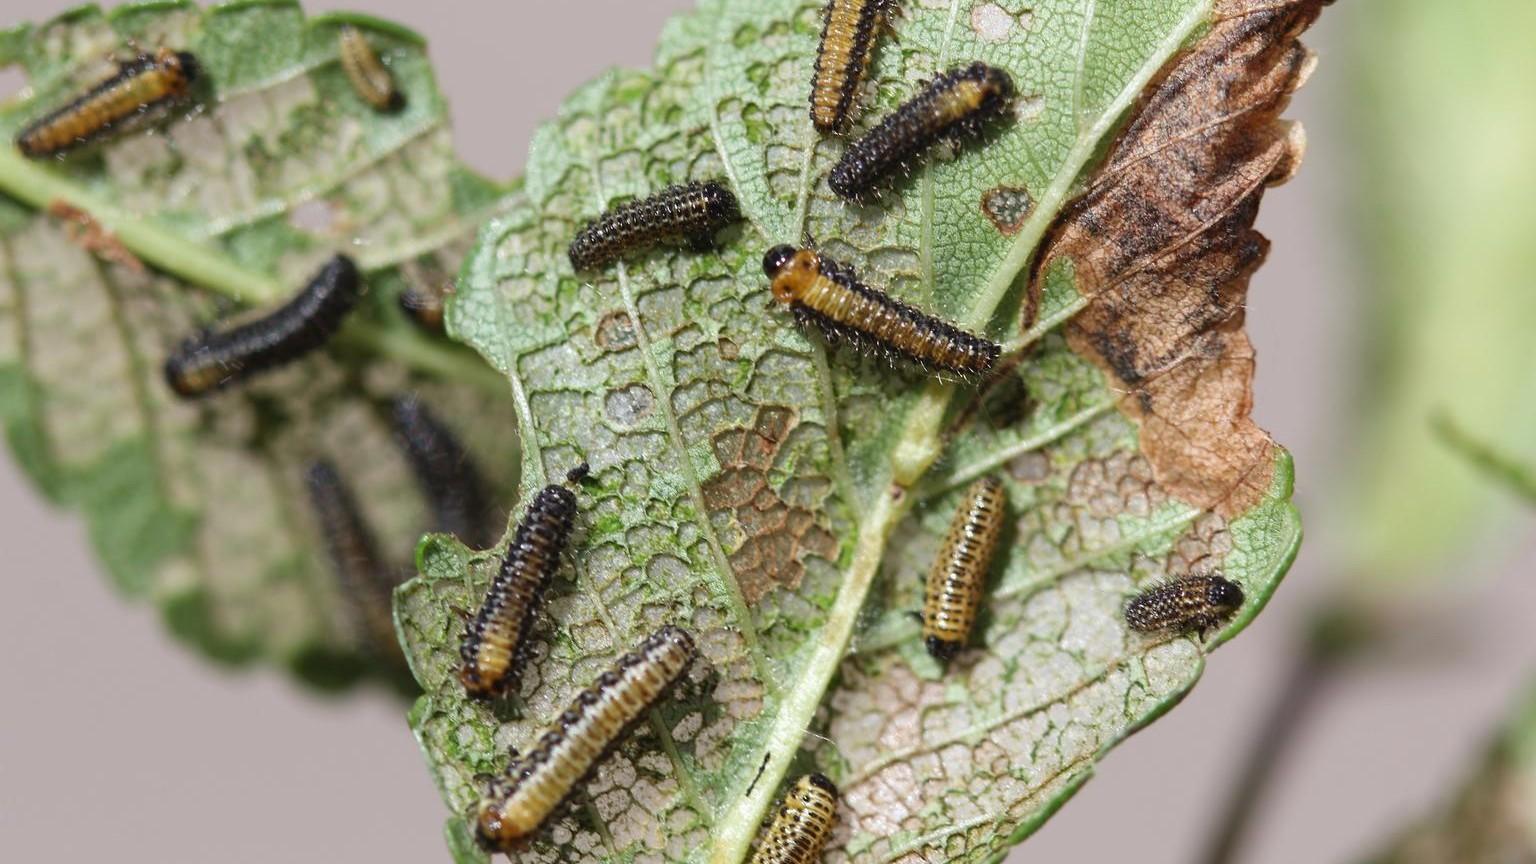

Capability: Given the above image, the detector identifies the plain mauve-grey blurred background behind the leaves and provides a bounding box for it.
[0,0,1536,864]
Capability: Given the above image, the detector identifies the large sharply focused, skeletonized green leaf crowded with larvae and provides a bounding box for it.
[396,0,1318,862]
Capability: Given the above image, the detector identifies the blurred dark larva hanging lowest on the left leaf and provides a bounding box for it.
[304,460,404,661]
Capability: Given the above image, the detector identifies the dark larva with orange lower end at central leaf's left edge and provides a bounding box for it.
[459,463,587,700]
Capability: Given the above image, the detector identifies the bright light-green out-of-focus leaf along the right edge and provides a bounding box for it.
[1335,0,1536,581]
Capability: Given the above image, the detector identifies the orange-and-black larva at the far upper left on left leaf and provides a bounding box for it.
[15,48,200,158]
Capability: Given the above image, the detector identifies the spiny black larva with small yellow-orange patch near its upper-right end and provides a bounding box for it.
[826,63,1014,200]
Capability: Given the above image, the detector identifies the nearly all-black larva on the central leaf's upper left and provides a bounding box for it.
[570,180,742,271]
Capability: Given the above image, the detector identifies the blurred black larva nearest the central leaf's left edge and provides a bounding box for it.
[390,397,501,549]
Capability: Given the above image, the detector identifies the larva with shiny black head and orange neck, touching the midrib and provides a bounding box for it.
[763,246,1001,378]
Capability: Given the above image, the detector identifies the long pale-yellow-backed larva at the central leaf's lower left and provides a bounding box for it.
[475,626,697,852]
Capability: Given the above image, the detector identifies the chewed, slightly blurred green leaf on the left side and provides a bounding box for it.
[0,2,518,686]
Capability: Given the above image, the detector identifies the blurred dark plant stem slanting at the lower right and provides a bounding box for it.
[1198,640,1339,864]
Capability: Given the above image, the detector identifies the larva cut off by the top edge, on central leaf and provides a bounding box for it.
[811,0,894,134]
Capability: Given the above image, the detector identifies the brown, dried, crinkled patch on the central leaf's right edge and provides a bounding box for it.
[1025,0,1330,517]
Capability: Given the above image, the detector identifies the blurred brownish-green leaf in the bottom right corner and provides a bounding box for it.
[1370,679,1536,864]
